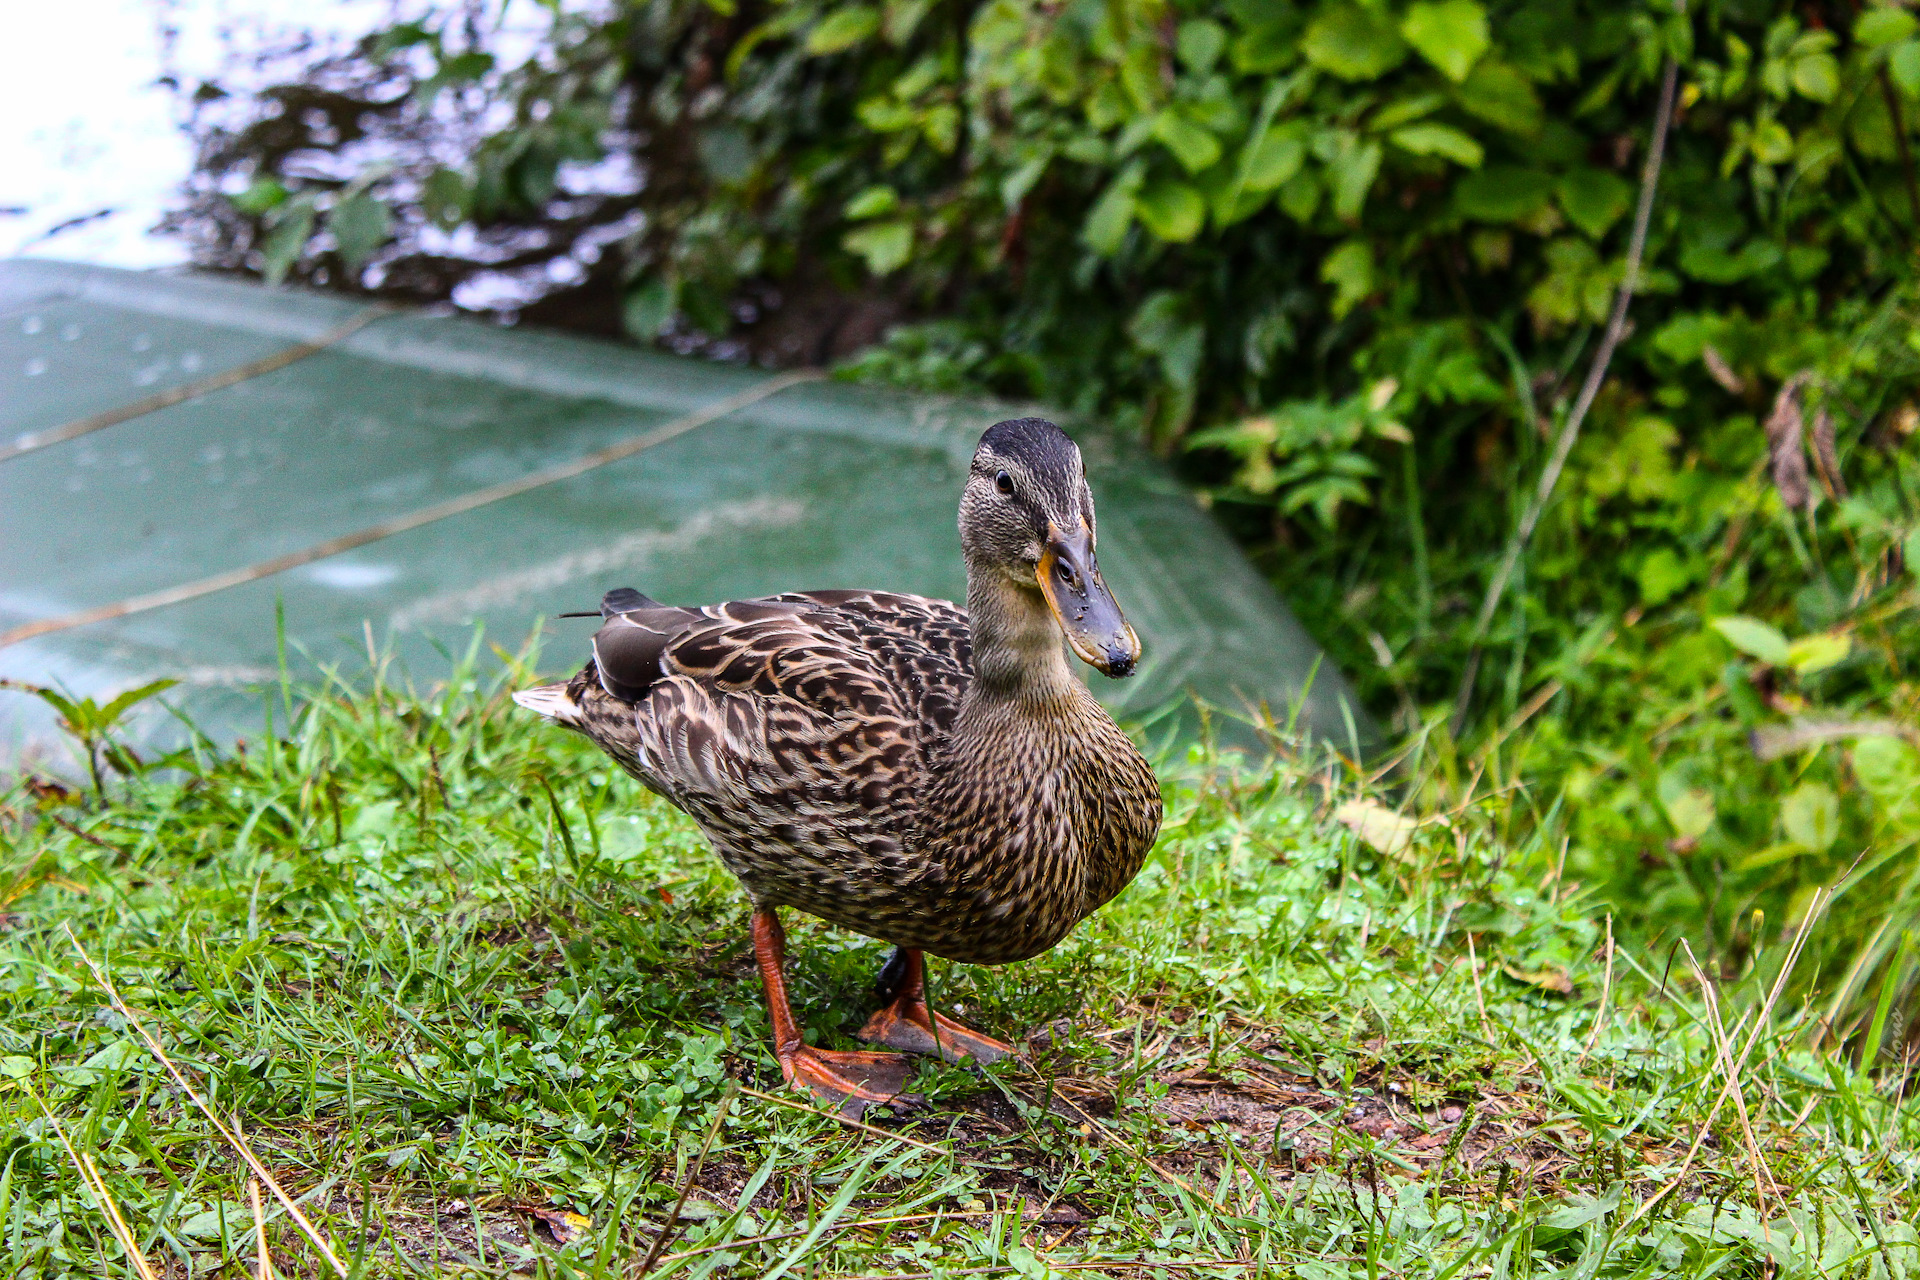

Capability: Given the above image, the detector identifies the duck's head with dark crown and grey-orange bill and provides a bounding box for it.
[960,418,1140,677]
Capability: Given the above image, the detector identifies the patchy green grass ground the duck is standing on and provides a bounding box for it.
[0,652,1920,1278]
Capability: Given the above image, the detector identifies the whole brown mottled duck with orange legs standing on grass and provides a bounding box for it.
[515,418,1160,1107]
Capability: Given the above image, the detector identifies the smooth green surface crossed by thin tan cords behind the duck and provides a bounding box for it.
[0,261,1365,756]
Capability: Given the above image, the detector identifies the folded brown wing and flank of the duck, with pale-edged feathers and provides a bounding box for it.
[593,591,968,905]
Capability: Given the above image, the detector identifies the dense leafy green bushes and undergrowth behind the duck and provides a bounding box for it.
[186,0,1920,1052]
